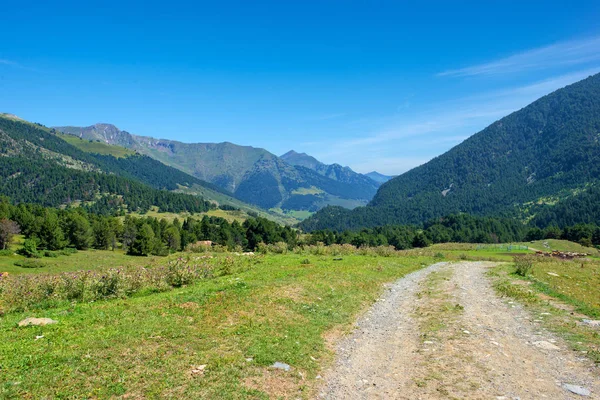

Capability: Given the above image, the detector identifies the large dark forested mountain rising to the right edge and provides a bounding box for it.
[301,74,600,230]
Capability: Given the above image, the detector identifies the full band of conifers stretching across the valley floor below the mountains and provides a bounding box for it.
[0,198,600,256]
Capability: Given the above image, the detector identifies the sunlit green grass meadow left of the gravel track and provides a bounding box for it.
[0,254,432,399]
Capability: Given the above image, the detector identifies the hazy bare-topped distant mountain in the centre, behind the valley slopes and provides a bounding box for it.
[56,124,376,211]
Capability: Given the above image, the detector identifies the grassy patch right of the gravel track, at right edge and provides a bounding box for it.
[490,257,600,362]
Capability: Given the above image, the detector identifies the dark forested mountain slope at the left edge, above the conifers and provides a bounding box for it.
[0,114,214,212]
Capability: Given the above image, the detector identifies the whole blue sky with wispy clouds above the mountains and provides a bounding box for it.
[0,0,600,174]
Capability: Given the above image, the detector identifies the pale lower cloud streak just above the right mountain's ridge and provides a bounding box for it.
[307,67,600,174]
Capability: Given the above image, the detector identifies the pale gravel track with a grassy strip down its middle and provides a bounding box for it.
[319,262,600,399]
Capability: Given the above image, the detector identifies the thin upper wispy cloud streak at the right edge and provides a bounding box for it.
[437,36,600,77]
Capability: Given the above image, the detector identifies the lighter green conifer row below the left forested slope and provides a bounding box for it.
[0,197,298,256]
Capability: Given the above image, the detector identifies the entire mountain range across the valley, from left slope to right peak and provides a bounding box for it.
[0,74,600,231]
